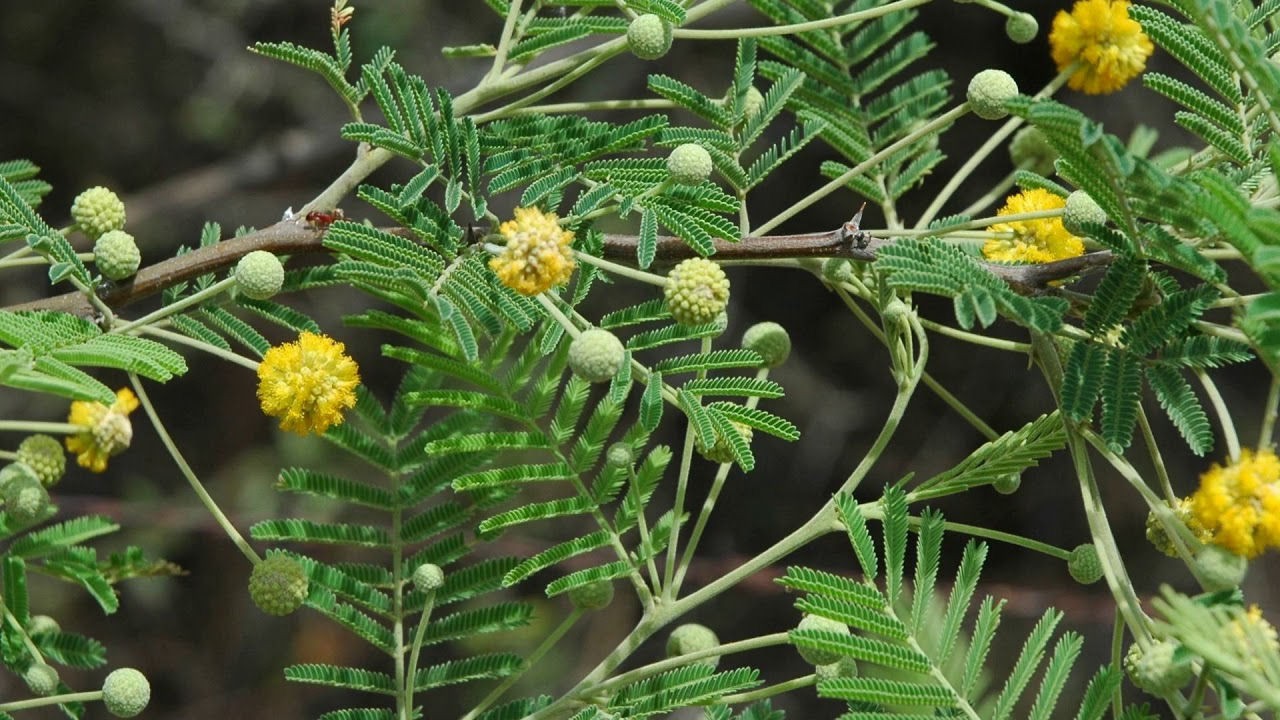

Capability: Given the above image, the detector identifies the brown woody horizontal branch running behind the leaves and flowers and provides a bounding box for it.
[5,217,1112,318]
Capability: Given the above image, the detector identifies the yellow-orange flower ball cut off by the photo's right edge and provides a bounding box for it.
[1190,450,1280,557]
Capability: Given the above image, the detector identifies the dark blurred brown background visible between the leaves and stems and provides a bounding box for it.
[0,0,1277,720]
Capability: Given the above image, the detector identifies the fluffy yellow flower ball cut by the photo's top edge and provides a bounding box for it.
[1048,0,1155,95]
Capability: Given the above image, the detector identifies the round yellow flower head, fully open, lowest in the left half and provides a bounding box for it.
[257,333,360,436]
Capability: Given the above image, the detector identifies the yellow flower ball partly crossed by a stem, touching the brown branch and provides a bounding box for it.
[982,187,1084,263]
